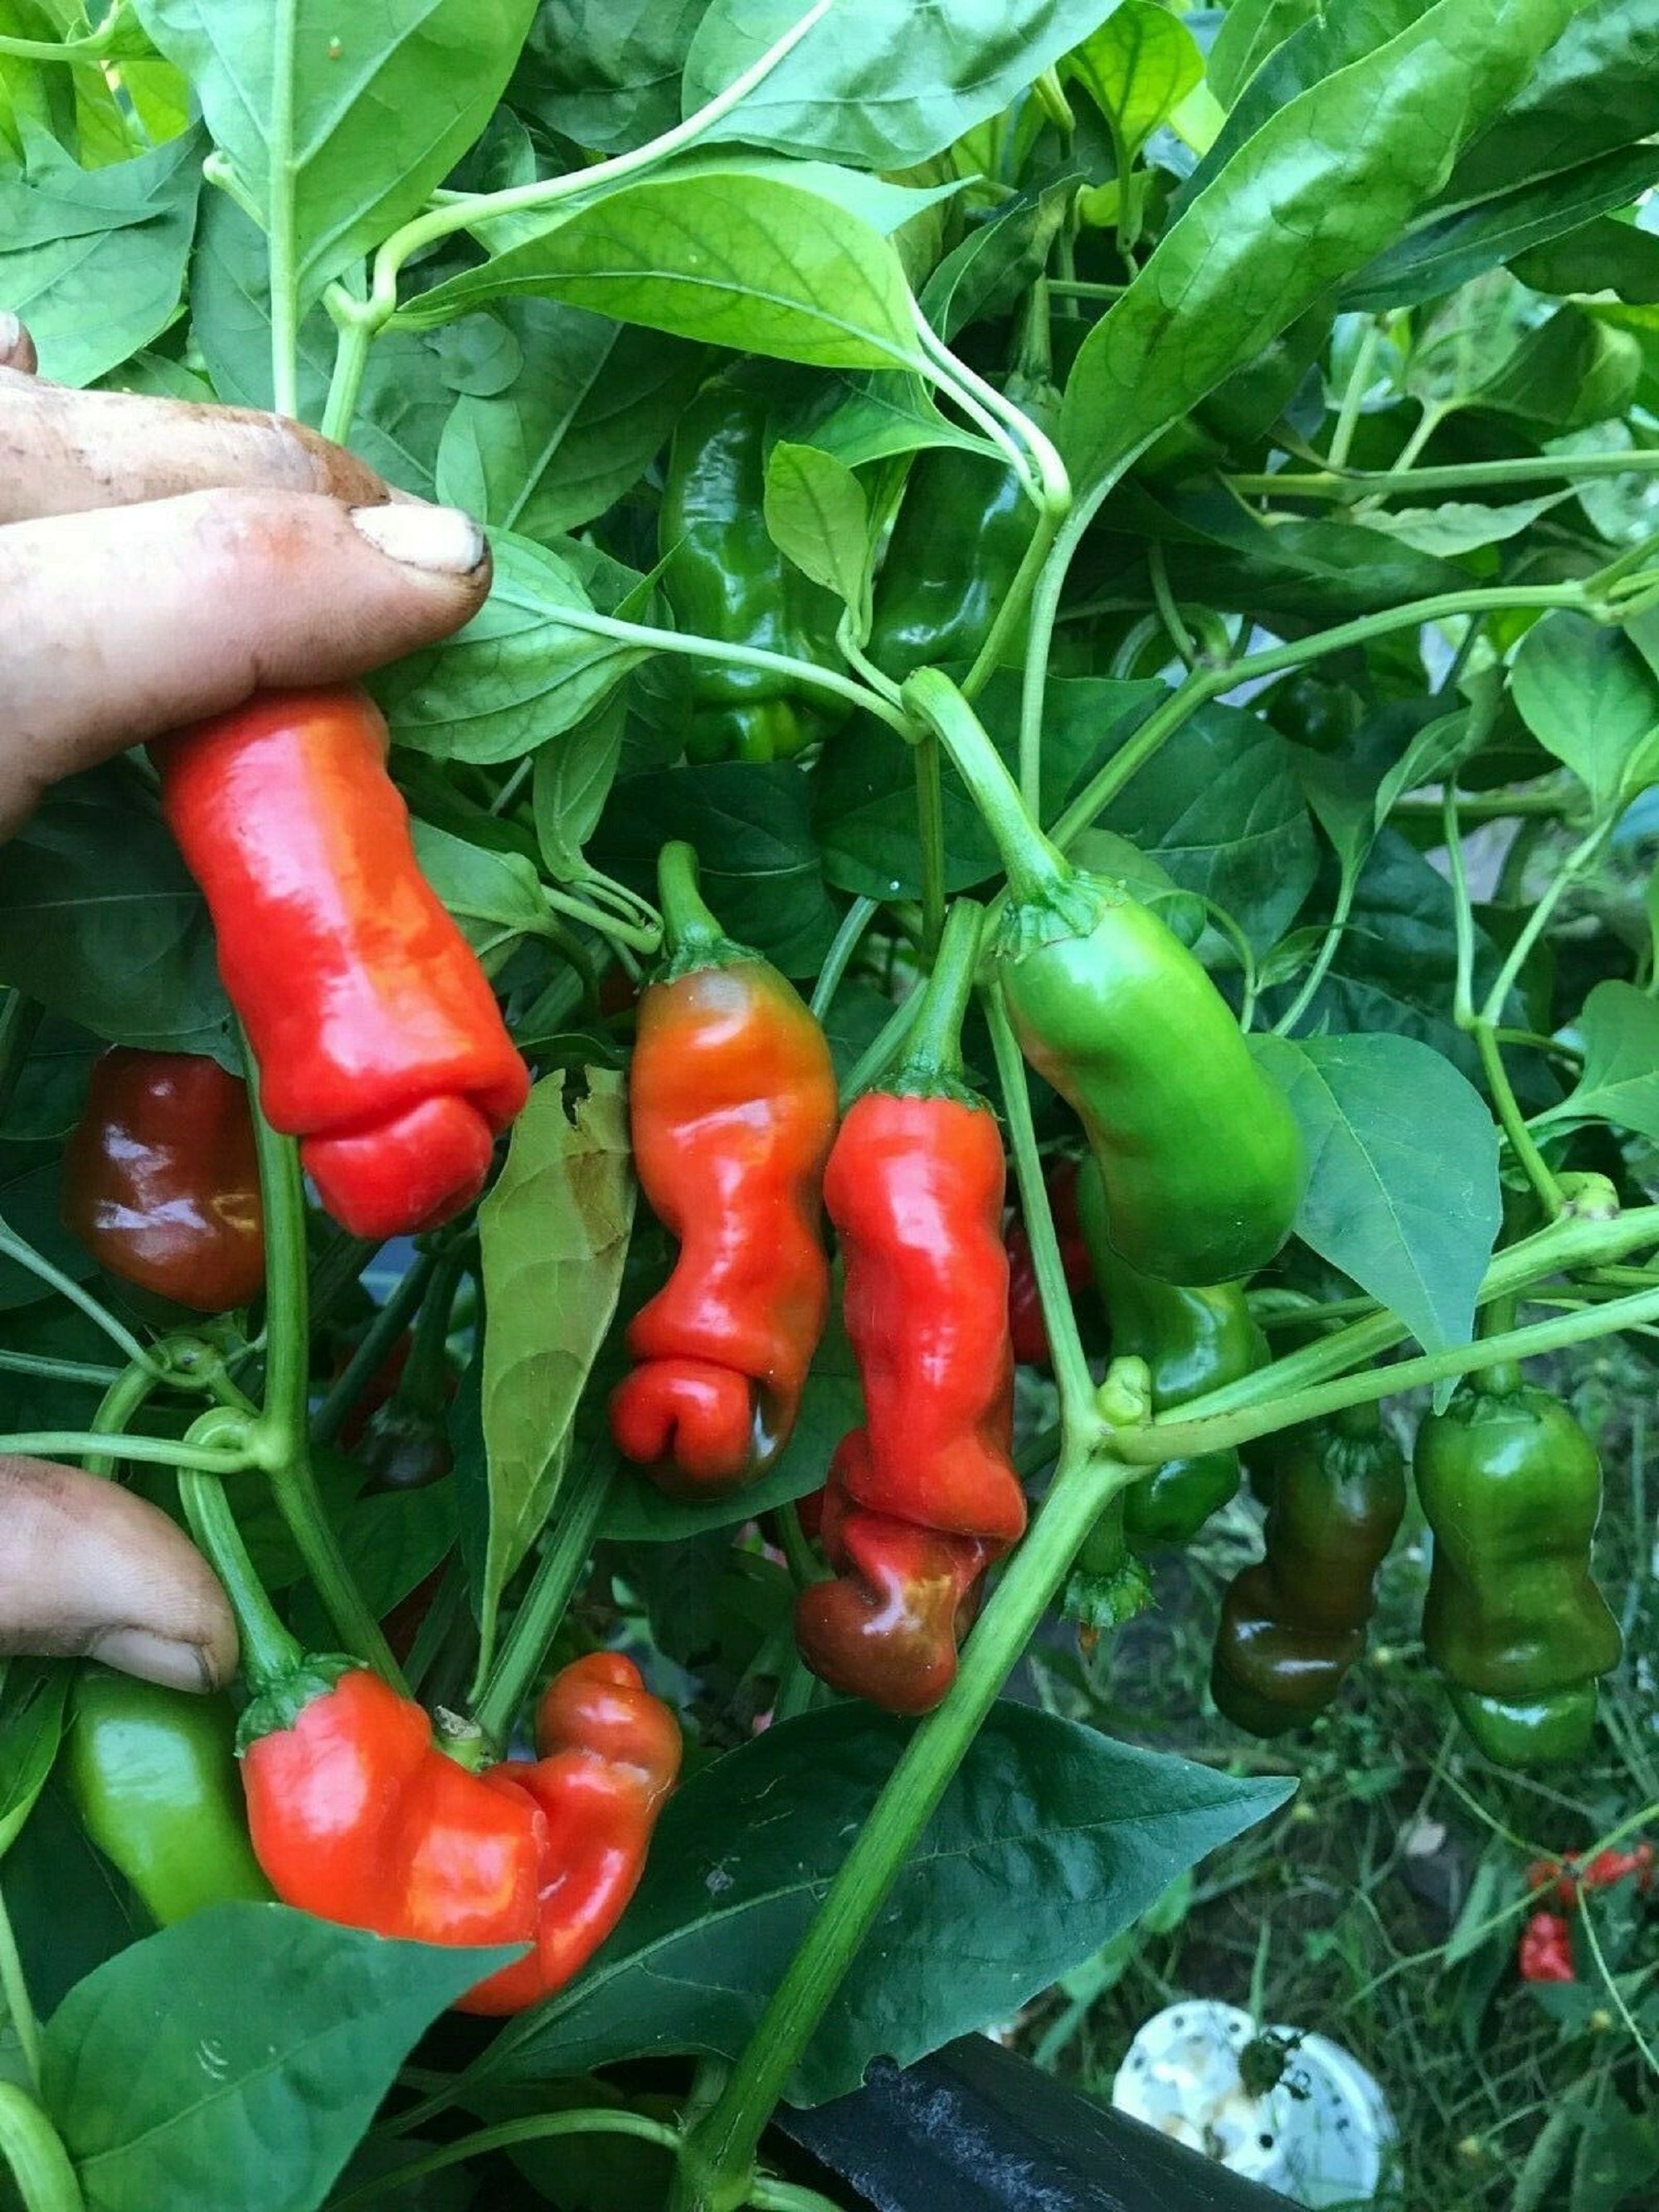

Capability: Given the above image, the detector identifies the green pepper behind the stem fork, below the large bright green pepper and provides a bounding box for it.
[1078,1159,1267,1551]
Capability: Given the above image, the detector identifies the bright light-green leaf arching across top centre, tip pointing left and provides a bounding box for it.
[402,157,920,369]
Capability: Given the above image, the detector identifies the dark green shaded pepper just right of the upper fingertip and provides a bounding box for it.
[659,376,847,761]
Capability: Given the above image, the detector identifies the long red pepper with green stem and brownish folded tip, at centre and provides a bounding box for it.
[796,903,1026,1712]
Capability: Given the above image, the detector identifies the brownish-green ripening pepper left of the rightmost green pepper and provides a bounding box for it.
[1210,1405,1404,1737]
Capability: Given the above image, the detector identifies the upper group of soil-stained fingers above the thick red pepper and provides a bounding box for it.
[0,312,491,836]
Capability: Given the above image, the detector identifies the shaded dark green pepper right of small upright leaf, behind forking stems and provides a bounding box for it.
[869,374,1059,681]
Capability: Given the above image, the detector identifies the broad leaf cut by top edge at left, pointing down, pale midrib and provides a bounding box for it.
[135,0,535,308]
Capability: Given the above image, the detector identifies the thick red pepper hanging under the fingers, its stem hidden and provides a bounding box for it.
[150,688,528,1236]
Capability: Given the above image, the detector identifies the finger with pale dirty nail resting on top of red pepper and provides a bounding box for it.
[0,491,489,836]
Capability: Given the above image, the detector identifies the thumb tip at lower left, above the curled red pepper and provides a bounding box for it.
[0,1454,236,1690]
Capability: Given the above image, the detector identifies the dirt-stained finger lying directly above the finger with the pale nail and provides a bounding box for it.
[0,358,387,522]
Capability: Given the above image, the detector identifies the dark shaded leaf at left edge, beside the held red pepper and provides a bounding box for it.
[0,765,230,1053]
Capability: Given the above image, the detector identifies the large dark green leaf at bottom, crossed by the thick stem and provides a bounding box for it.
[469,1703,1290,2103]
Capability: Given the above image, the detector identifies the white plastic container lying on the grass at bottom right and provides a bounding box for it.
[1112,2000,1398,2208]
